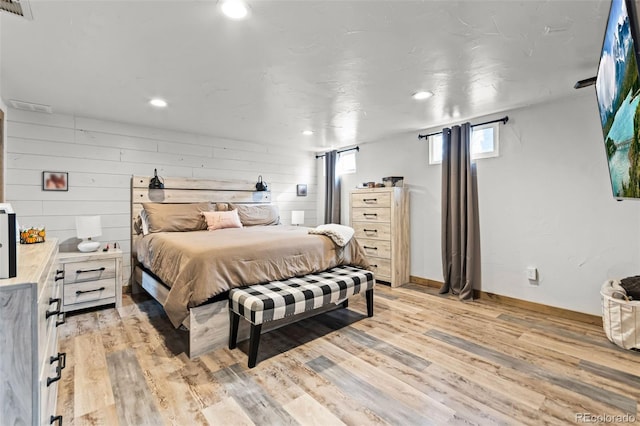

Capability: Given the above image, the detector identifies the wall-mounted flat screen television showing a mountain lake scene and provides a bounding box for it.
[596,0,640,199]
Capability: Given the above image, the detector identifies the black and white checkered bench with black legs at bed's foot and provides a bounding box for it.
[229,266,375,368]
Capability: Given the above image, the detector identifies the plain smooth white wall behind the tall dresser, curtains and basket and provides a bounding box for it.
[343,89,640,315]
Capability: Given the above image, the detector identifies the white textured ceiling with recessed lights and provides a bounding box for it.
[0,0,610,150]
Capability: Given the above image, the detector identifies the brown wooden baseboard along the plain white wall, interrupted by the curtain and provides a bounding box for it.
[409,275,602,327]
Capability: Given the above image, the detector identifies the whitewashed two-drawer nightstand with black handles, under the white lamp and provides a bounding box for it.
[58,249,122,312]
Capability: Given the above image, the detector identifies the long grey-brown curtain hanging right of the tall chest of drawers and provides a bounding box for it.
[440,123,480,300]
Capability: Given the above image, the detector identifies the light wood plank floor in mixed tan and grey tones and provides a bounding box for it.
[58,285,640,426]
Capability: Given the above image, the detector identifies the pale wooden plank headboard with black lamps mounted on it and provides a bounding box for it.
[131,176,271,273]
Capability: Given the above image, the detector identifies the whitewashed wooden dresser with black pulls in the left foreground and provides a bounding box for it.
[0,239,65,425]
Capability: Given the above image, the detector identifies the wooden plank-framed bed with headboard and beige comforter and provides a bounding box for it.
[131,176,368,358]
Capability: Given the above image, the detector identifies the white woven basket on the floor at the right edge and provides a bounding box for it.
[600,280,640,350]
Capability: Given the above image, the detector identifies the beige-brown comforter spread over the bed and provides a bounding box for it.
[136,225,369,327]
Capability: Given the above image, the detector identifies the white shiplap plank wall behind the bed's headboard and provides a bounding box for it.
[5,109,318,285]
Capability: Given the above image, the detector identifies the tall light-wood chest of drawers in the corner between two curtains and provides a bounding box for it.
[351,187,410,287]
